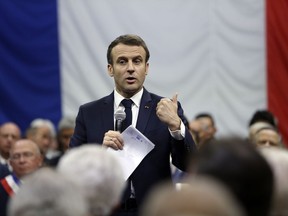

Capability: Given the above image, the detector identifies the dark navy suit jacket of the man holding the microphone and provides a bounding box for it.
[70,89,196,204]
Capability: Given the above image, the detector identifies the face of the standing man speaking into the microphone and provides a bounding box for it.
[108,44,149,98]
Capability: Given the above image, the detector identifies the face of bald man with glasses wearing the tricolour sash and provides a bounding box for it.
[10,140,42,178]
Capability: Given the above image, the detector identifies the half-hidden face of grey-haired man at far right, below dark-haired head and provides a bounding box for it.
[255,129,280,147]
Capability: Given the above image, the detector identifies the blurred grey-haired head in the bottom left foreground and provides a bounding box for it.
[8,168,88,216]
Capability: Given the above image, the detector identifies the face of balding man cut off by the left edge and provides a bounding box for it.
[0,123,21,159]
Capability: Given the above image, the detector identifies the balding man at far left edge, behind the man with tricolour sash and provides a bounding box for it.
[0,122,21,171]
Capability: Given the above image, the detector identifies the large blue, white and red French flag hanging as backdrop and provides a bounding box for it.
[0,0,288,144]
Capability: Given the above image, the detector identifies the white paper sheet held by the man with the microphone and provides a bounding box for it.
[107,125,155,180]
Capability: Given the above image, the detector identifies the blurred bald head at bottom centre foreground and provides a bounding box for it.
[140,177,245,216]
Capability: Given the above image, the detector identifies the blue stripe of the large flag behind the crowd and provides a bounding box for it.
[0,0,61,131]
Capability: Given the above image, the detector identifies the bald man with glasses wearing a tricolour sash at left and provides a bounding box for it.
[0,139,43,216]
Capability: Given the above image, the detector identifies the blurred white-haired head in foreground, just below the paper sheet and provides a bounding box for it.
[58,144,125,216]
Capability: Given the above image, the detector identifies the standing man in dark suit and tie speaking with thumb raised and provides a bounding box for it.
[70,35,196,215]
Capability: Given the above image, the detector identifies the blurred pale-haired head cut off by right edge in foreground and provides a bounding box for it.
[259,147,288,216]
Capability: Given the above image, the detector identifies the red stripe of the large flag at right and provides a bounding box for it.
[266,0,288,146]
